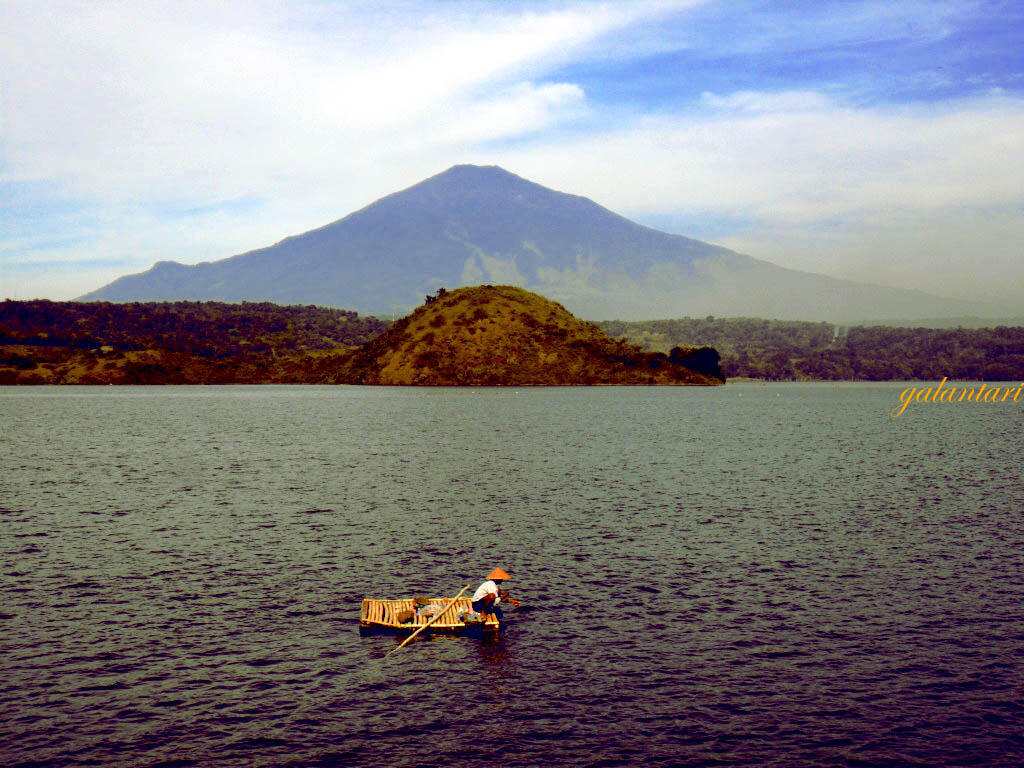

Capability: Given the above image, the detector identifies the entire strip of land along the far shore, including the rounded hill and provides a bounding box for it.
[14,296,1024,385]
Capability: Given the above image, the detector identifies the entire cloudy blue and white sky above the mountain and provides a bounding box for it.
[0,0,1024,314]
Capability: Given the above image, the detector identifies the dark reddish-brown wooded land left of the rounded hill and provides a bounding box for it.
[0,300,387,384]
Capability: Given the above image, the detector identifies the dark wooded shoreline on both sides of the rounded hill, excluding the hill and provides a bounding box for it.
[0,300,1024,384]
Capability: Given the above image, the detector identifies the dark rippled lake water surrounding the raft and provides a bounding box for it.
[0,384,1024,768]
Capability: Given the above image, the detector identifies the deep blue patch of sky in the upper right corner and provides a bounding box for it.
[552,1,1024,110]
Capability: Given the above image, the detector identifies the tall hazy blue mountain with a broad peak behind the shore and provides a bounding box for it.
[80,165,991,323]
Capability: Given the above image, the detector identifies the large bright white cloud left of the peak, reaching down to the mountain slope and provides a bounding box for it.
[0,0,664,298]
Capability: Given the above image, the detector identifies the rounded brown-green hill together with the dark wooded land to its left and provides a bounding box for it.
[0,286,723,386]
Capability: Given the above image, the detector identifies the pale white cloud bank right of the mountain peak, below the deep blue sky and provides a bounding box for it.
[481,92,1024,305]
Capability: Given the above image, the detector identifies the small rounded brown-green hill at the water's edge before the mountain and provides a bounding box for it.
[327,286,724,386]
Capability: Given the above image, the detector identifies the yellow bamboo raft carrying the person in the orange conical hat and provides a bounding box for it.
[359,597,501,634]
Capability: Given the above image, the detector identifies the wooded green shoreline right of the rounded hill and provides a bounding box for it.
[599,317,1024,381]
